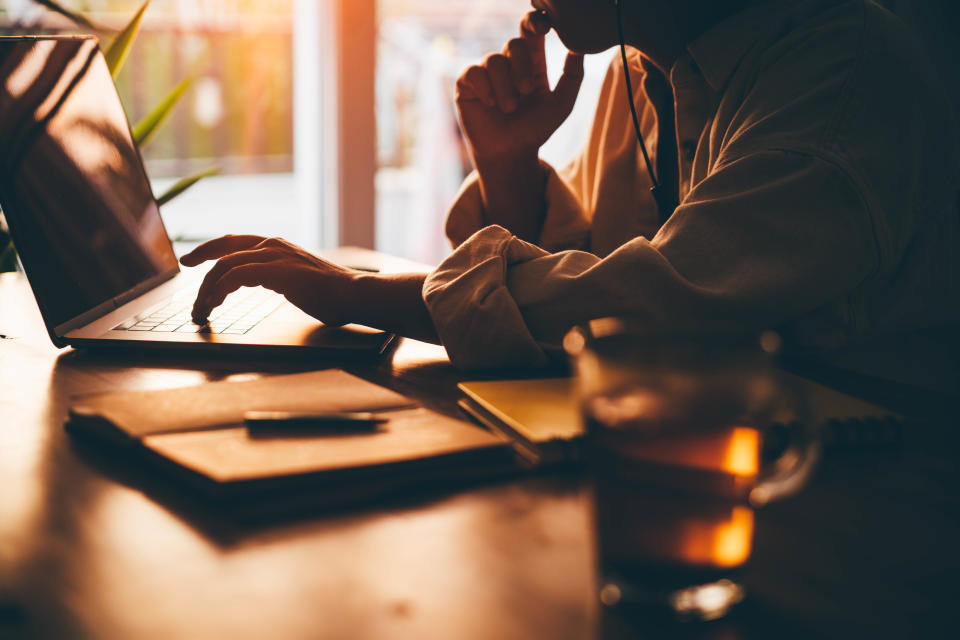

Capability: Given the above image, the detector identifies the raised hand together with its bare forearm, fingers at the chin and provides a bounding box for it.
[456,12,583,242]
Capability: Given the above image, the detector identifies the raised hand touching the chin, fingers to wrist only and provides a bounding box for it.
[456,11,583,166]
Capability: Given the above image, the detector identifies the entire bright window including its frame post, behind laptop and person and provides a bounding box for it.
[0,0,613,263]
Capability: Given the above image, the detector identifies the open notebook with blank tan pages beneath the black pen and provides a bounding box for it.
[66,370,516,501]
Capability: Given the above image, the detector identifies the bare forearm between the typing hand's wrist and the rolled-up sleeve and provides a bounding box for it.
[352,273,440,344]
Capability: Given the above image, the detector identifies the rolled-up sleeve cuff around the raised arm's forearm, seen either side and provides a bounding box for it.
[446,162,590,251]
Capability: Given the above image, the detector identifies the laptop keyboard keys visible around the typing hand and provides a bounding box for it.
[114,287,284,335]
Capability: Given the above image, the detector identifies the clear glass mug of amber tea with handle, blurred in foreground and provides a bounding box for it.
[564,319,818,620]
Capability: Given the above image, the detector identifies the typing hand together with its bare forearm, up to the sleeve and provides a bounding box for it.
[180,235,437,341]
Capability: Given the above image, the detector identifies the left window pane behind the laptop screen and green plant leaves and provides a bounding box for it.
[0,0,300,244]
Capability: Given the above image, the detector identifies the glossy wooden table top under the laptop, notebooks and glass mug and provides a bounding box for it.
[0,256,960,639]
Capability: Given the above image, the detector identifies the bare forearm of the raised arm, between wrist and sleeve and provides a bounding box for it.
[474,151,547,243]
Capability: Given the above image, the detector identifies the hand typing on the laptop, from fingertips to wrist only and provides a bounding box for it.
[180,236,358,326]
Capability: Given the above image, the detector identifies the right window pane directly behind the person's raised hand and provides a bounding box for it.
[376,0,614,263]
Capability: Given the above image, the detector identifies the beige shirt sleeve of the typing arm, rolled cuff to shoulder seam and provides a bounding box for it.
[423,150,877,369]
